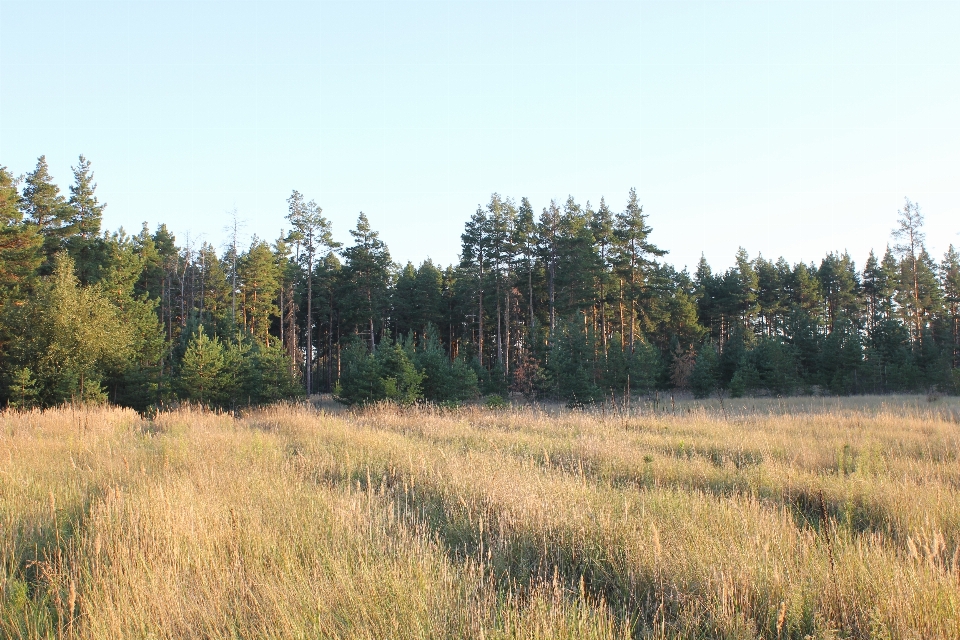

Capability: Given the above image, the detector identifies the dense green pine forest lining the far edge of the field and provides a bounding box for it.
[0,156,960,411]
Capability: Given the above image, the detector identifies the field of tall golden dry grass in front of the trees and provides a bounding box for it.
[0,397,960,638]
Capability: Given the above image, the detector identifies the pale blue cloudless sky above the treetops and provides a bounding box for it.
[0,0,960,271]
